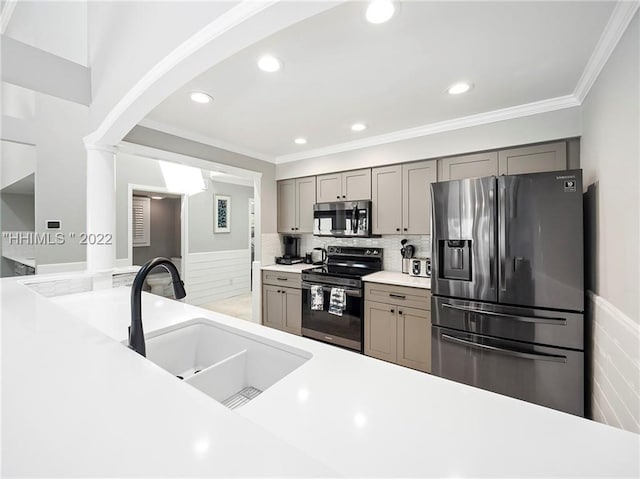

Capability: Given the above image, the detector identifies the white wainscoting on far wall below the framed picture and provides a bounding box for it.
[184,249,251,306]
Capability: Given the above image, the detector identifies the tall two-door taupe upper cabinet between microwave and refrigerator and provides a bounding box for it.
[371,160,437,235]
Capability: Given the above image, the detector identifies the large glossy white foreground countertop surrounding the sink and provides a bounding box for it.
[0,272,640,477]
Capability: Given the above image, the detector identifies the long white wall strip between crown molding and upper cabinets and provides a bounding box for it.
[276,107,580,180]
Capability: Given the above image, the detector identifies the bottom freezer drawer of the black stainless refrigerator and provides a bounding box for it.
[431,326,584,416]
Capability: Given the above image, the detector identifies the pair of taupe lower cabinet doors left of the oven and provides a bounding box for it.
[262,284,302,336]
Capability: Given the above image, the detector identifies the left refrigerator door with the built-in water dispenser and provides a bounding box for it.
[431,176,498,302]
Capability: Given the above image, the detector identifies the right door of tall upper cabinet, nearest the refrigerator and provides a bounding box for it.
[402,160,437,235]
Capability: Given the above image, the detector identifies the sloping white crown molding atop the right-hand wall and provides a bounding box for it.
[573,0,640,104]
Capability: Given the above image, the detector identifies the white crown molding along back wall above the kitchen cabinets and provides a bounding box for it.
[276,95,580,164]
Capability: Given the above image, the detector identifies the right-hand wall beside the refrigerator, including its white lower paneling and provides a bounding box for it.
[581,14,640,432]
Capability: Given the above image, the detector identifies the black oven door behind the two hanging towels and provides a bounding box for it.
[302,282,364,352]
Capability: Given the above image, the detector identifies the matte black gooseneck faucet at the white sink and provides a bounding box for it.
[129,258,187,357]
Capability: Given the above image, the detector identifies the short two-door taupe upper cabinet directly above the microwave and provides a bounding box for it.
[316,168,371,203]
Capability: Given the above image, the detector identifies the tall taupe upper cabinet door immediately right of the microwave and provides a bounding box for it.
[371,165,402,235]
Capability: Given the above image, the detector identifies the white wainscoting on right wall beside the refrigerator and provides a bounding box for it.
[587,291,640,433]
